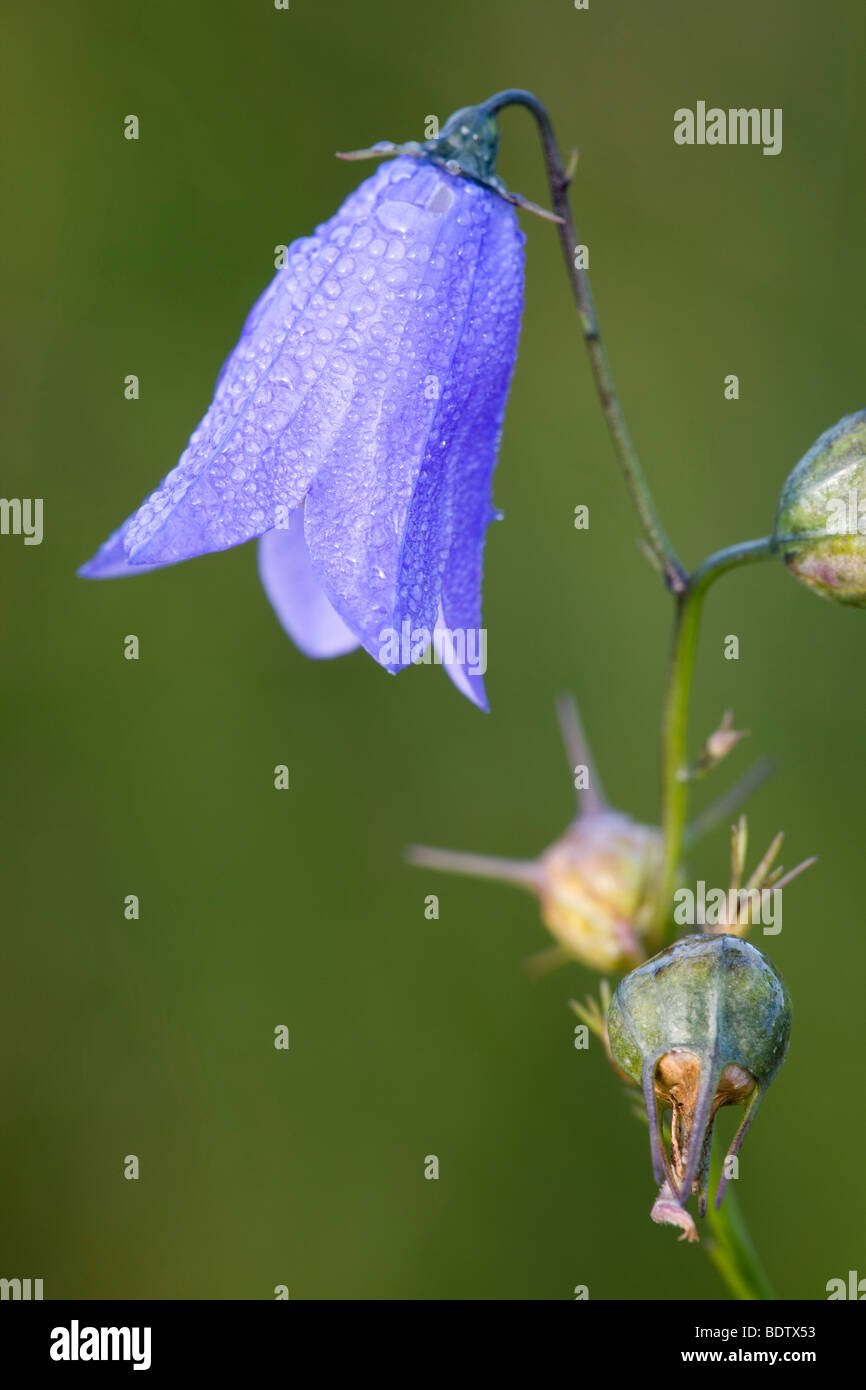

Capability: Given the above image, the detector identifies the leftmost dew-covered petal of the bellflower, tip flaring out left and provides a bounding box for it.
[83,160,436,574]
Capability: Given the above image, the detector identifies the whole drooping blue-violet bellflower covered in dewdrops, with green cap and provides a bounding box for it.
[79,108,524,709]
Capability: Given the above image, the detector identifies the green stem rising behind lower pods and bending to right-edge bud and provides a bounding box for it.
[656,537,773,945]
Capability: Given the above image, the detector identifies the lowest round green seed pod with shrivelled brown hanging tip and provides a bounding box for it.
[607,935,791,1240]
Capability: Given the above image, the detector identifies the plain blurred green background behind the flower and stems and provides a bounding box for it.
[0,0,866,1300]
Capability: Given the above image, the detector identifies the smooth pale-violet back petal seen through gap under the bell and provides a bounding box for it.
[259,510,360,657]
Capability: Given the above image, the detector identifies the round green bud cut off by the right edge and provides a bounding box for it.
[773,410,866,607]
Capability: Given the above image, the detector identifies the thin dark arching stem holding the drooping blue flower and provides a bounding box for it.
[482,88,687,594]
